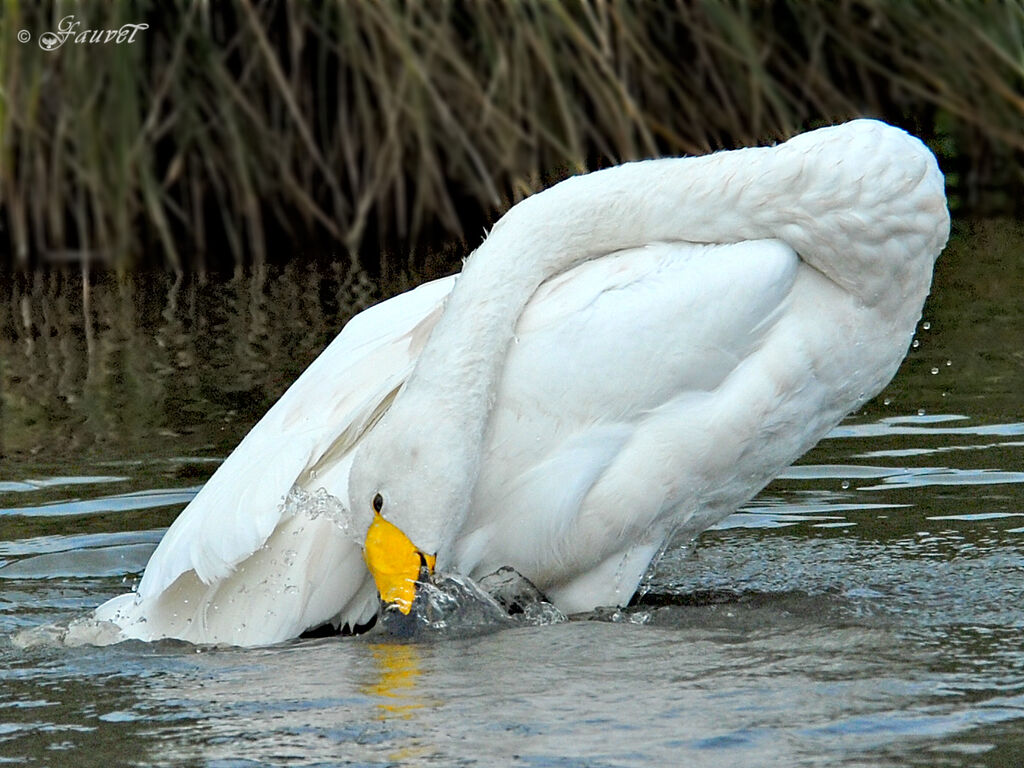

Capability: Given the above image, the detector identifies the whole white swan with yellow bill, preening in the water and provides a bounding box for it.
[96,120,949,645]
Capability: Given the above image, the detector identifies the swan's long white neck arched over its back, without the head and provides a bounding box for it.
[392,121,948,548]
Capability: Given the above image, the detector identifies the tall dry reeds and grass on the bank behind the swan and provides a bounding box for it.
[0,0,1024,271]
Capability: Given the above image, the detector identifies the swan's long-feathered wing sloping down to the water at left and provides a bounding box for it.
[138,276,455,599]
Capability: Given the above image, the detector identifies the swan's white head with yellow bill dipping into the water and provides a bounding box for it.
[348,408,472,613]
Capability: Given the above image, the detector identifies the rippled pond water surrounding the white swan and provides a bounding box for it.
[0,219,1024,766]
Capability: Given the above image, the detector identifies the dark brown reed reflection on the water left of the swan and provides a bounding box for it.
[0,264,389,462]
